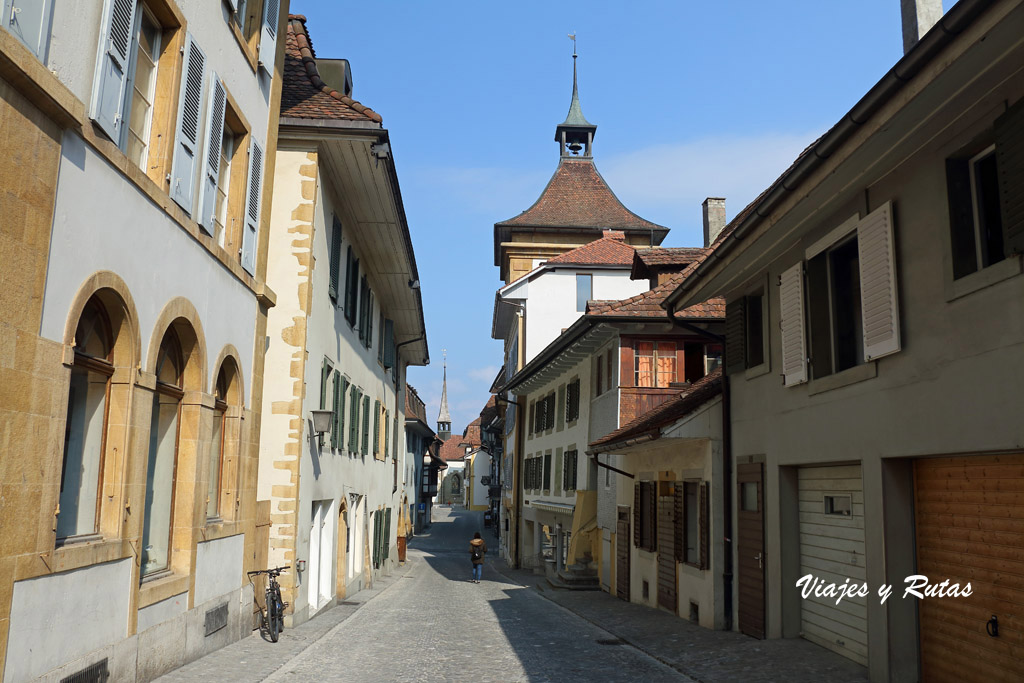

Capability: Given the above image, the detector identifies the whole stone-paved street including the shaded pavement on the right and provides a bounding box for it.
[160,507,867,683]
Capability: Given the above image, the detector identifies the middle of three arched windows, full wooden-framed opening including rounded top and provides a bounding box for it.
[142,329,184,577]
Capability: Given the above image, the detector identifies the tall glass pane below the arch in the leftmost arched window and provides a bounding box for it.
[57,368,108,539]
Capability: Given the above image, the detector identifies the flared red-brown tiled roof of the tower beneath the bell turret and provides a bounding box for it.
[495,158,669,235]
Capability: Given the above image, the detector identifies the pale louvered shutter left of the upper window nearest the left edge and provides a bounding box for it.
[92,0,135,144]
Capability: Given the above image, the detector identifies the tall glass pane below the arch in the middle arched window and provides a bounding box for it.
[142,393,178,577]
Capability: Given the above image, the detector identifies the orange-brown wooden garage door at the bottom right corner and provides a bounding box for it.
[913,454,1024,681]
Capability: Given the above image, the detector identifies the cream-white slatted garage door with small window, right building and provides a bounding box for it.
[800,465,867,666]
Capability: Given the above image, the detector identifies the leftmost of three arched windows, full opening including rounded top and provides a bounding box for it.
[57,299,114,545]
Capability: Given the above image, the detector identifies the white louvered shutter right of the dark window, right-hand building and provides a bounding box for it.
[857,202,900,360]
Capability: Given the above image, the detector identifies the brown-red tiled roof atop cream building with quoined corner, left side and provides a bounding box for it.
[281,14,382,124]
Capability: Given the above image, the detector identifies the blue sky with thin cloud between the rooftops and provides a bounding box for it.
[299,0,952,432]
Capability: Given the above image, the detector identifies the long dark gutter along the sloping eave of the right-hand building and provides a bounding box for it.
[663,0,993,307]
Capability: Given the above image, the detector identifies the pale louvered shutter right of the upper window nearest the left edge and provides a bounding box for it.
[171,34,206,216]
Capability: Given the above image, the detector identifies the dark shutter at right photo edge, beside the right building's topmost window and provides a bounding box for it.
[995,100,1024,256]
